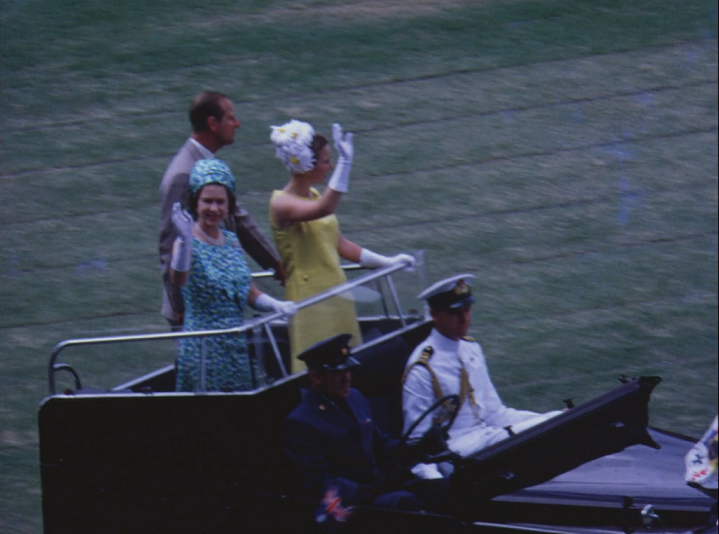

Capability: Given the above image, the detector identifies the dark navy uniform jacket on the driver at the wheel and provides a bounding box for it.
[285,389,397,504]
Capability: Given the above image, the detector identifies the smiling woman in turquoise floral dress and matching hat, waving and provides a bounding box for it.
[170,159,297,391]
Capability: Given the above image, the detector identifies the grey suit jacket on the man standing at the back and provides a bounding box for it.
[159,139,280,319]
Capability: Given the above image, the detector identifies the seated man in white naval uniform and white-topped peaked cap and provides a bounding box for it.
[402,274,561,478]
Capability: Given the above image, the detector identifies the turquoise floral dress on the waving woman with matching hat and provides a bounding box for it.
[175,230,252,391]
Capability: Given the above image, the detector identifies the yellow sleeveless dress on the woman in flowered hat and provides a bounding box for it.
[270,188,362,373]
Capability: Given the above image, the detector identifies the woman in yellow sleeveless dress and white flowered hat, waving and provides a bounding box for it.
[270,120,414,373]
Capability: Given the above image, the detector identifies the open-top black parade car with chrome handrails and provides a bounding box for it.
[39,267,717,534]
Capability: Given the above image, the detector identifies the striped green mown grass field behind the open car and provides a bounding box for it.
[0,0,718,533]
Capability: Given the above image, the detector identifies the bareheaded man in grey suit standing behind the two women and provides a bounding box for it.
[159,91,284,330]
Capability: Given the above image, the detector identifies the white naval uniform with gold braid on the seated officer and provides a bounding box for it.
[402,329,561,478]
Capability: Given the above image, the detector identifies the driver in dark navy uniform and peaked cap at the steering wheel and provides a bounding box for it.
[285,334,446,510]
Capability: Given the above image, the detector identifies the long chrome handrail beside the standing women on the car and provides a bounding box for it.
[48,262,409,395]
